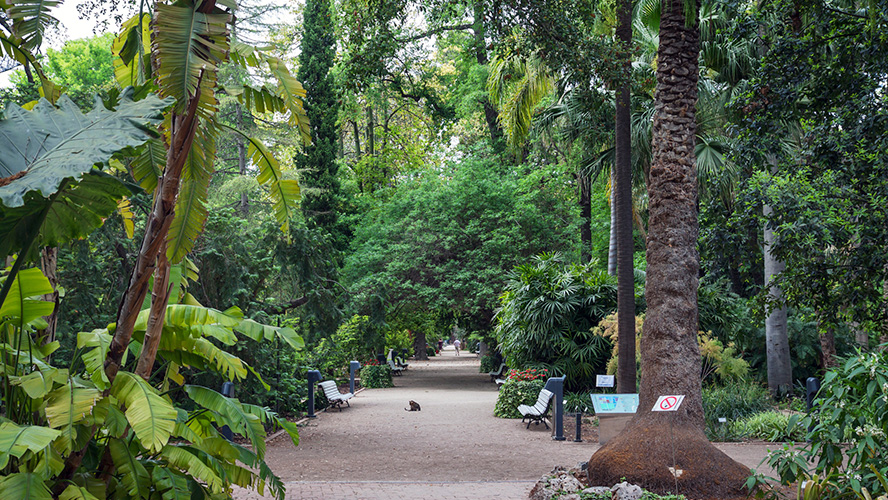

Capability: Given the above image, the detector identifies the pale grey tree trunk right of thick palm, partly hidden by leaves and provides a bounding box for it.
[762,155,792,396]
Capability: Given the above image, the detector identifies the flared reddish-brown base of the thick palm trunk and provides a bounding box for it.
[587,418,750,500]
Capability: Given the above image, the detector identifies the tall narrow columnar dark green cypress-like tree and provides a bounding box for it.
[296,0,347,250]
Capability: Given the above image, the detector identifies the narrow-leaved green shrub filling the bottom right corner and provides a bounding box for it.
[767,351,888,497]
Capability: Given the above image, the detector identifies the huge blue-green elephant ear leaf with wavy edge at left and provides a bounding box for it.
[0,89,171,259]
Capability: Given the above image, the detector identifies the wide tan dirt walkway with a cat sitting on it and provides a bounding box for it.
[236,350,776,499]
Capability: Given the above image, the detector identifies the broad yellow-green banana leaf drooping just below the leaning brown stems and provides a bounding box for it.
[111,371,178,452]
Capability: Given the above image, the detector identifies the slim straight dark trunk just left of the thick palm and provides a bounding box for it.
[611,0,638,394]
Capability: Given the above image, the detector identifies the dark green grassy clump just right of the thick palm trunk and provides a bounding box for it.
[703,382,772,438]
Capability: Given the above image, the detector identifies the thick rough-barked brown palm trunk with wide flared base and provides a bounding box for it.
[588,0,750,492]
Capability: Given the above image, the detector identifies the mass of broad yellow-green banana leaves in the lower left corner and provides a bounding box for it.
[0,269,303,500]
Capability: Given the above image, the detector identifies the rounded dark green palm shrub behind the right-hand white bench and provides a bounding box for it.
[495,253,617,391]
